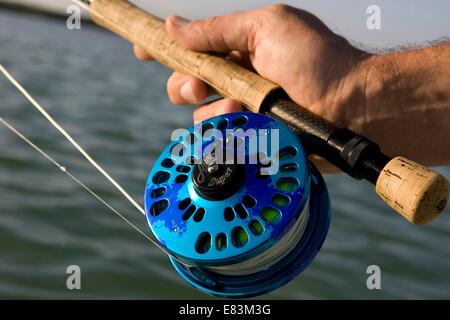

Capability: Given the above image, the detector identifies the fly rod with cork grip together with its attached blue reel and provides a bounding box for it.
[61,0,449,297]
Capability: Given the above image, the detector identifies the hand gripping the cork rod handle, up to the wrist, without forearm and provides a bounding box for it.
[135,5,368,126]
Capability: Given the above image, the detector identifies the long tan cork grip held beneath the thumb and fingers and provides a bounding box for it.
[90,0,279,112]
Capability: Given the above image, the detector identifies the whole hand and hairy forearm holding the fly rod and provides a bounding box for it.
[135,5,450,172]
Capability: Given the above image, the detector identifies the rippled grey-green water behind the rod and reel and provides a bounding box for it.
[0,11,450,299]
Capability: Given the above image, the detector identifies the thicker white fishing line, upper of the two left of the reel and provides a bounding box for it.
[0,64,145,216]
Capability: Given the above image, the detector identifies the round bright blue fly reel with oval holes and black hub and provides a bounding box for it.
[145,113,330,298]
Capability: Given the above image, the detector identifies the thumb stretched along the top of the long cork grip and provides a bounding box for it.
[166,11,258,52]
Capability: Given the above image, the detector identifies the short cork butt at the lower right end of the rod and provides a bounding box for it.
[376,157,449,224]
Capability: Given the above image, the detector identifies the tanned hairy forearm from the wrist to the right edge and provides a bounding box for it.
[348,44,450,165]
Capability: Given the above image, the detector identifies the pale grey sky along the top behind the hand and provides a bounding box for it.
[0,0,450,49]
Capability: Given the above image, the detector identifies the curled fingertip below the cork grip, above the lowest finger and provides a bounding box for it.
[167,72,214,104]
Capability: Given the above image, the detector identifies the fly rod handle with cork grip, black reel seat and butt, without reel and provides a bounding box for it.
[75,0,449,224]
